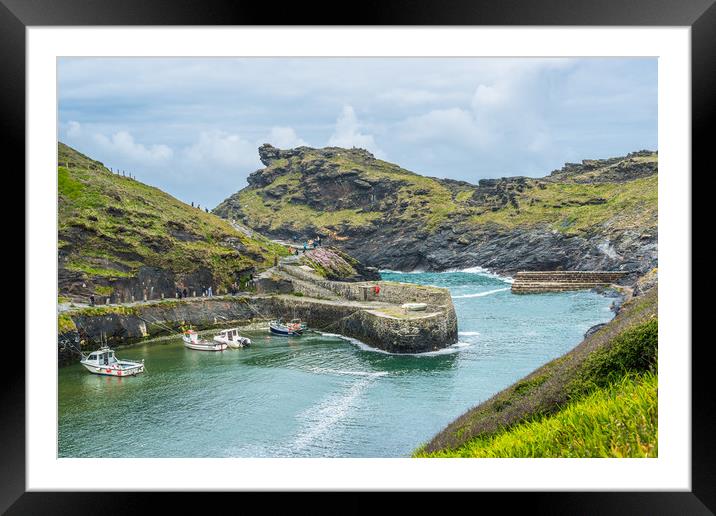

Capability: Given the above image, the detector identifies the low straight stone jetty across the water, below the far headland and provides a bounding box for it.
[512,271,629,294]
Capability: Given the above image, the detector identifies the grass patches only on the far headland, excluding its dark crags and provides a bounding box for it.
[228,150,658,235]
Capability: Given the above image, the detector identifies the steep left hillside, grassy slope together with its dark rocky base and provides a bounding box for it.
[57,143,287,303]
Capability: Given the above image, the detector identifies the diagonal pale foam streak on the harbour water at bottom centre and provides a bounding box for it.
[291,376,377,452]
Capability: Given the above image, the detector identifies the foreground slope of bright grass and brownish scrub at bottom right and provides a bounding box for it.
[416,288,658,457]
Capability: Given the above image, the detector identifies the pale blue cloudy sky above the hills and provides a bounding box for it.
[58,57,657,208]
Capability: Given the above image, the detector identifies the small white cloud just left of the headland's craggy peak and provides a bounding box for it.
[184,130,258,167]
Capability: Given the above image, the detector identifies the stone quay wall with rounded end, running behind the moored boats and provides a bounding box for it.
[58,288,457,364]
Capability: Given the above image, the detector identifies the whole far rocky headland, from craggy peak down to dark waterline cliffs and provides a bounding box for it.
[214,145,658,276]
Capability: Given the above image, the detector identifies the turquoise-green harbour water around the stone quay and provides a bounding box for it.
[59,272,612,457]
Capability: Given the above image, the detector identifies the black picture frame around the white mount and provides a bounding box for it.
[0,0,716,515]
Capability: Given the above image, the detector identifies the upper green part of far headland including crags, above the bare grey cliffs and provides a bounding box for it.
[216,148,657,237]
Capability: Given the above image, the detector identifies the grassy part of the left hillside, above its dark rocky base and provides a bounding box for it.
[57,143,286,293]
